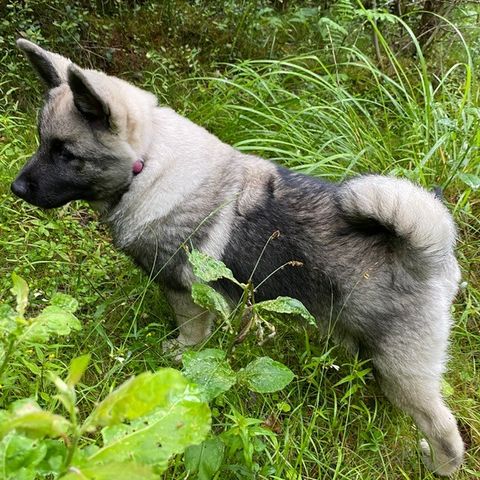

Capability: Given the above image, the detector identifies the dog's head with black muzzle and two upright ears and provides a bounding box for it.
[11,39,157,208]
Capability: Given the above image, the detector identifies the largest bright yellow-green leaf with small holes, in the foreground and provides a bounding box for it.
[86,369,211,471]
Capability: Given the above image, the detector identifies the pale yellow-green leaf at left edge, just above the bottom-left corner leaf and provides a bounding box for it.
[0,400,70,438]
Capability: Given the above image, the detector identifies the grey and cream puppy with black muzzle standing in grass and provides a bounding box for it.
[11,39,464,475]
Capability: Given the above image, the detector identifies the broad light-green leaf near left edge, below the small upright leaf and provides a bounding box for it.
[19,305,82,343]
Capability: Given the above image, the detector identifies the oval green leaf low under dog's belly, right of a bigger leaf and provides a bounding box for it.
[238,357,295,393]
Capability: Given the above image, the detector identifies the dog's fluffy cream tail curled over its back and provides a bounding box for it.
[339,175,456,276]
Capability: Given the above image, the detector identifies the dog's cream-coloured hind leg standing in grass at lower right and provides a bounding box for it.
[372,320,464,475]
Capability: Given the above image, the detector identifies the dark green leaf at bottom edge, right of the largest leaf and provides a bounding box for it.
[184,437,225,480]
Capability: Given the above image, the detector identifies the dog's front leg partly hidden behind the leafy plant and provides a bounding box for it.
[166,290,213,349]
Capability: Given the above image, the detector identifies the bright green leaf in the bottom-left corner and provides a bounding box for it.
[0,432,47,480]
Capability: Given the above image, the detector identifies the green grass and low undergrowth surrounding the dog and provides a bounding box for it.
[0,1,480,480]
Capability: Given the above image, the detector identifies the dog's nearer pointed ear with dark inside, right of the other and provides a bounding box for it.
[68,63,111,128]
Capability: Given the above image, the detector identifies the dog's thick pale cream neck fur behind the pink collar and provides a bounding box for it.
[92,107,235,248]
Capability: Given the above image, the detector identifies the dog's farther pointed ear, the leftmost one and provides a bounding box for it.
[17,38,71,88]
